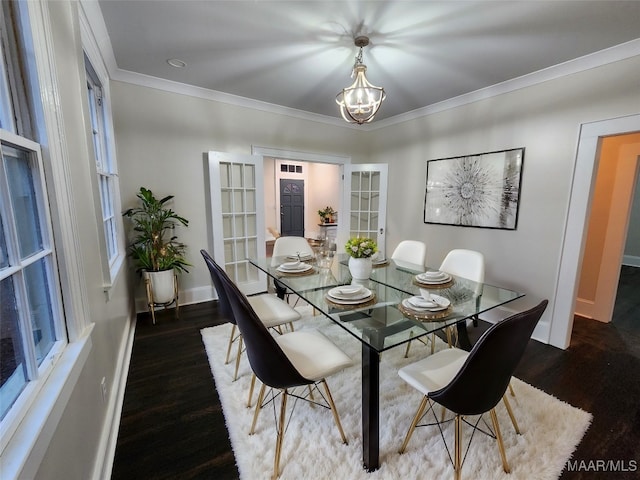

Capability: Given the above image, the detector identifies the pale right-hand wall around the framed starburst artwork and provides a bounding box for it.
[368,57,640,341]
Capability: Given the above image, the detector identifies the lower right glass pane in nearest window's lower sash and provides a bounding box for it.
[24,258,56,365]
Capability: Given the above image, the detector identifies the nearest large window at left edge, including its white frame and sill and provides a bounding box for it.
[0,0,91,464]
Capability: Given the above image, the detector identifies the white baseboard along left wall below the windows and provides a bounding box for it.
[91,317,136,480]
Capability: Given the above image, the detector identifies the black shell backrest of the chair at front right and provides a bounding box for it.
[429,300,548,415]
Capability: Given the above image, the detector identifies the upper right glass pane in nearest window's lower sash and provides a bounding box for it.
[2,145,43,258]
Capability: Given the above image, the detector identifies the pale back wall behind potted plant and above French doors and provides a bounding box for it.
[112,82,366,303]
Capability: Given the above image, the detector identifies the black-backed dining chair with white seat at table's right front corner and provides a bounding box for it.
[398,300,548,480]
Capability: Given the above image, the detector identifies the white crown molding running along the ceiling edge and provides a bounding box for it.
[80,5,640,131]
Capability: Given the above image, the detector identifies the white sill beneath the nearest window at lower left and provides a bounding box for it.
[0,324,93,480]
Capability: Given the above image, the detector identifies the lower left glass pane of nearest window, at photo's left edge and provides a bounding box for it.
[0,277,27,418]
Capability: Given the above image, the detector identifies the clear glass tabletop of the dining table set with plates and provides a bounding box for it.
[249,254,523,352]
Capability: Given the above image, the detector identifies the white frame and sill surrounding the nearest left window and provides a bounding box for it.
[0,0,93,479]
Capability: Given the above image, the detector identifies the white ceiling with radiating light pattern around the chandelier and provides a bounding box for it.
[99,0,640,122]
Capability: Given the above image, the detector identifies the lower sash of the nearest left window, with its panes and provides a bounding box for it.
[0,130,66,419]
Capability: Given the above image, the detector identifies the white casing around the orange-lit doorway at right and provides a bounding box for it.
[547,114,640,349]
